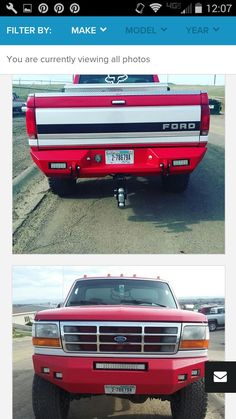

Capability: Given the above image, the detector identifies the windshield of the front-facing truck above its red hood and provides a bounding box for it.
[66,278,177,308]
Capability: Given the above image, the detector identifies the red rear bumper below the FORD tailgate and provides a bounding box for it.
[31,144,207,178]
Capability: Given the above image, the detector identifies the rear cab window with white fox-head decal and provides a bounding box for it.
[78,74,153,84]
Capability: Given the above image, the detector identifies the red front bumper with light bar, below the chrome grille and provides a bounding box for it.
[33,355,207,395]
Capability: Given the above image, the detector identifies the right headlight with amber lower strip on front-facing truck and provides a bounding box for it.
[179,325,209,350]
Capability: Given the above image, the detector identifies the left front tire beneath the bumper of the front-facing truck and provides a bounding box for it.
[32,374,70,419]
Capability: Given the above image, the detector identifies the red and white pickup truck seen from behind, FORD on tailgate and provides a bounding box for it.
[26,75,210,208]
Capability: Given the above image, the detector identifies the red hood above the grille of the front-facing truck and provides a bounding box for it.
[35,305,207,323]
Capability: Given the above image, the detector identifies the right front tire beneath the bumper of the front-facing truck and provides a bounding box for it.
[170,379,207,419]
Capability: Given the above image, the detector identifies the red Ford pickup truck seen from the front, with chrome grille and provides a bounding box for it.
[33,275,209,419]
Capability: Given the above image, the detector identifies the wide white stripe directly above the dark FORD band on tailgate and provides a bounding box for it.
[36,106,201,125]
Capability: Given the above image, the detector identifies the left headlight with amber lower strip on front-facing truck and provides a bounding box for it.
[32,322,61,348]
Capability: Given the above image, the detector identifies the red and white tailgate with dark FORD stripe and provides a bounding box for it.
[28,84,206,148]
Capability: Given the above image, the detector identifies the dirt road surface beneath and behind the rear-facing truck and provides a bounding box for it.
[13,115,224,254]
